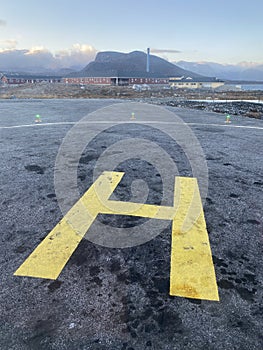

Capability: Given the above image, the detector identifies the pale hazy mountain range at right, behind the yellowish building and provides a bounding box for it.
[174,61,263,81]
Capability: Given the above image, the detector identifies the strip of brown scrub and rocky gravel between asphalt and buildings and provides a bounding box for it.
[0,83,263,119]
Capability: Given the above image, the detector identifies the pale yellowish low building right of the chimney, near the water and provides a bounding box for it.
[169,76,225,89]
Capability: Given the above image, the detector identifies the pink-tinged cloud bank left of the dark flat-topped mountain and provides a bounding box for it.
[0,44,97,72]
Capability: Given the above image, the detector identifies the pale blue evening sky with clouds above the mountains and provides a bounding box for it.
[0,0,263,69]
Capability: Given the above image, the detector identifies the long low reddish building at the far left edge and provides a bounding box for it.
[0,74,61,85]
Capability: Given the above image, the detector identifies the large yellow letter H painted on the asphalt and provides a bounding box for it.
[15,172,219,300]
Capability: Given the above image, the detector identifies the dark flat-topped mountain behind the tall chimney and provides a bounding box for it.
[69,51,204,78]
